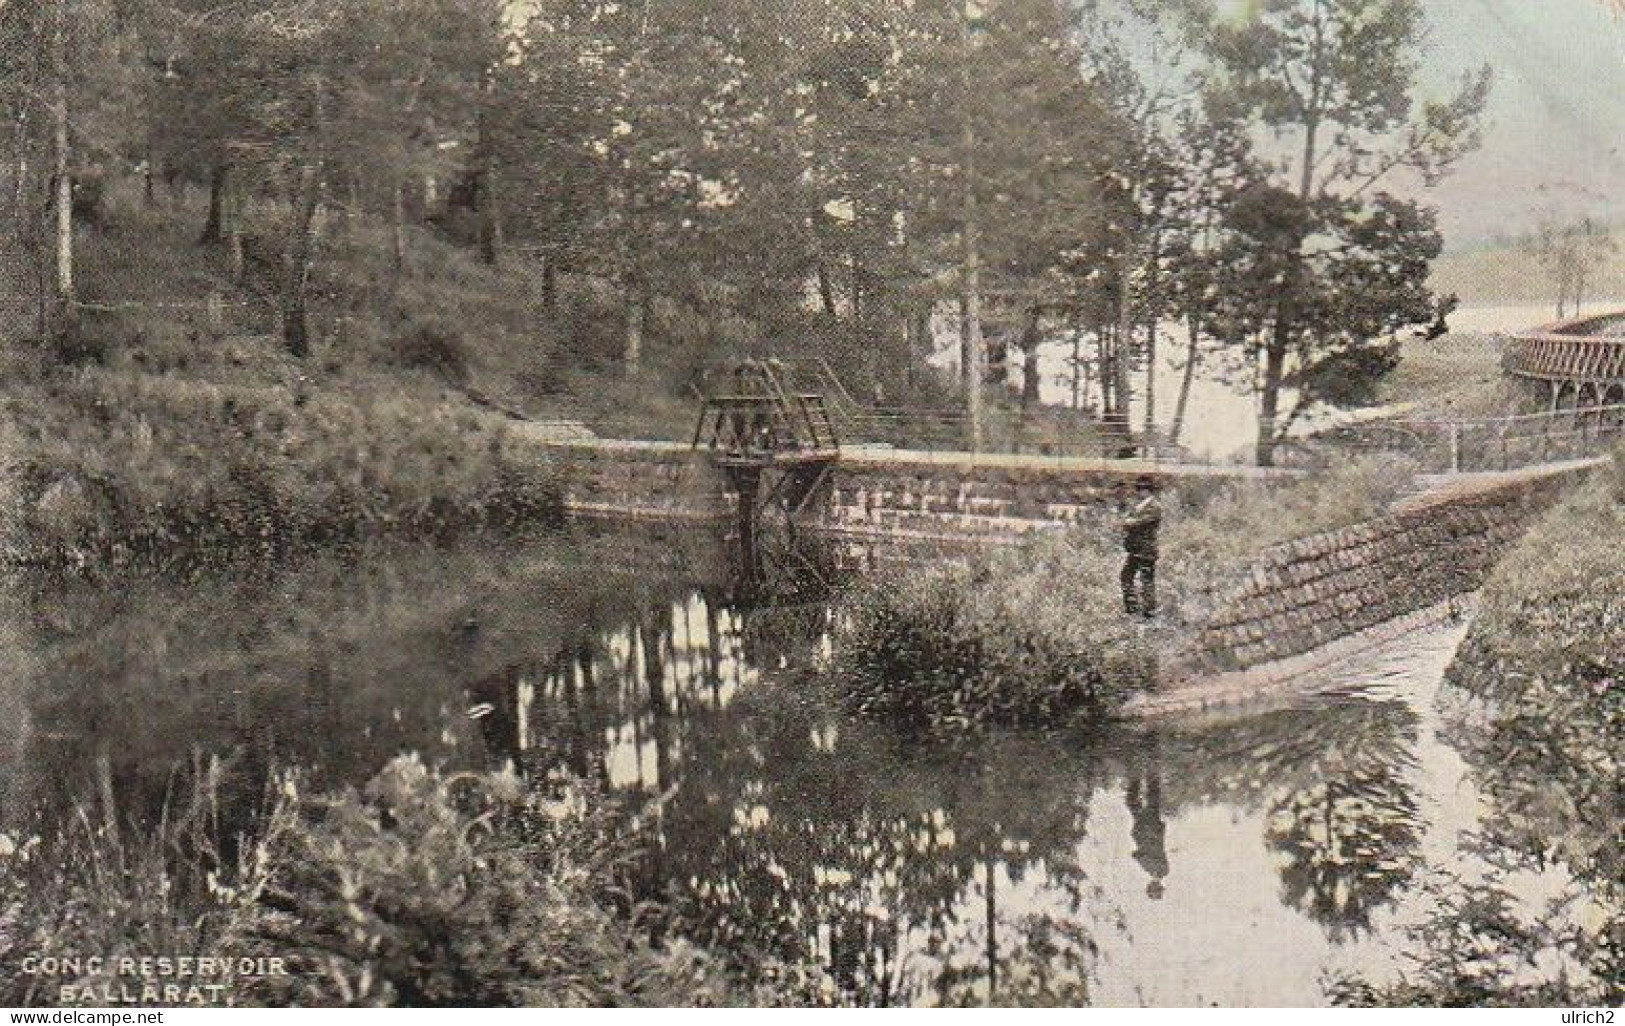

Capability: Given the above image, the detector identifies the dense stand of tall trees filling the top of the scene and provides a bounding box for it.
[0,0,1489,459]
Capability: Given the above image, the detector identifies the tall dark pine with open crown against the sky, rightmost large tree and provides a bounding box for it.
[1209,0,1490,465]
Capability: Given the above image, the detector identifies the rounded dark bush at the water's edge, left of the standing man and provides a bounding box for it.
[835,538,1155,730]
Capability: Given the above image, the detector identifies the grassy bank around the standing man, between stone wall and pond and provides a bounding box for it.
[834,459,1412,730]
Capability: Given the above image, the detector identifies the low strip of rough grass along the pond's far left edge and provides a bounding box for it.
[7,366,562,567]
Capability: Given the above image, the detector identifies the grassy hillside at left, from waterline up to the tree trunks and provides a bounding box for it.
[0,186,591,567]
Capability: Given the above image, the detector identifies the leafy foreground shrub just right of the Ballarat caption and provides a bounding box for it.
[247,758,728,1006]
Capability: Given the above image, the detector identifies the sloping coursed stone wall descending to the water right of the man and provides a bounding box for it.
[1165,470,1584,678]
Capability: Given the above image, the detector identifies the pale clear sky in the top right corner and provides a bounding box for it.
[1404,0,1625,249]
